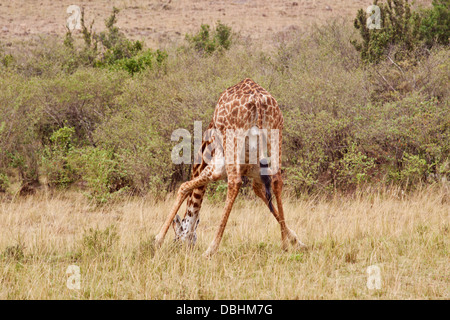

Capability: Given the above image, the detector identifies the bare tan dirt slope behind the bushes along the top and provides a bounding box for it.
[0,0,431,48]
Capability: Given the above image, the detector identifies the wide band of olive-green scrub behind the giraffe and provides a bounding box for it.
[0,16,450,199]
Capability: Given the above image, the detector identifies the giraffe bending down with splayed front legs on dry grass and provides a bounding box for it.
[155,78,305,257]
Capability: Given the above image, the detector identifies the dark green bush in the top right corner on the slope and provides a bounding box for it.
[351,0,450,63]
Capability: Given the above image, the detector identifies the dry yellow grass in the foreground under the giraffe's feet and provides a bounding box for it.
[0,186,450,299]
